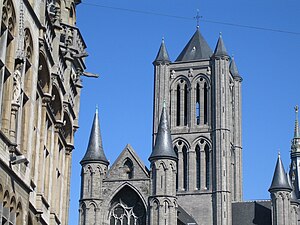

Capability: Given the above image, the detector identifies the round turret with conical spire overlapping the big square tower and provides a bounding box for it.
[149,106,177,225]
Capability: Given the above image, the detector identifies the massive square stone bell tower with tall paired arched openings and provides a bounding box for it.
[153,27,242,225]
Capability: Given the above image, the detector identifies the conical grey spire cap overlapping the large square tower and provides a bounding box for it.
[149,103,177,161]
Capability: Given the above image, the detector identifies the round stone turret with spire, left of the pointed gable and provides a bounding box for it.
[79,109,109,225]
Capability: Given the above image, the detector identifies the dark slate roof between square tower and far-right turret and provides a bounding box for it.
[232,201,272,225]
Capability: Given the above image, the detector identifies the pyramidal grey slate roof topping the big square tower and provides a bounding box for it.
[176,29,212,62]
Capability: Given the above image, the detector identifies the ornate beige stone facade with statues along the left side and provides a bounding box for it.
[0,0,86,225]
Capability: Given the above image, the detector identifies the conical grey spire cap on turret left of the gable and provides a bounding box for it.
[80,106,109,165]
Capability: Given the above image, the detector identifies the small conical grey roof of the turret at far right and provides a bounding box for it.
[269,154,292,192]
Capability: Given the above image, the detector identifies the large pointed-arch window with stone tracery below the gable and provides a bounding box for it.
[109,186,146,225]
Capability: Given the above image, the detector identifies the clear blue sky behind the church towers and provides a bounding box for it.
[69,0,300,225]
